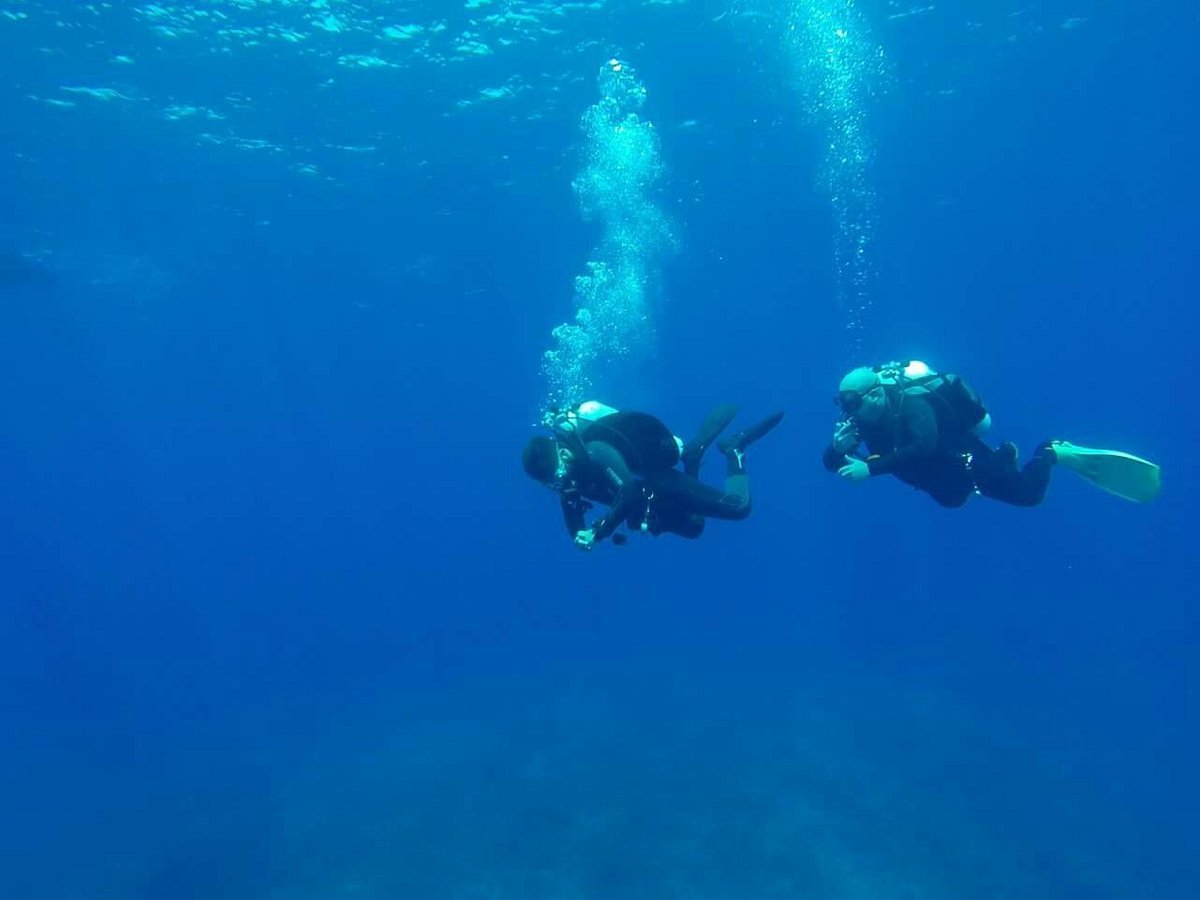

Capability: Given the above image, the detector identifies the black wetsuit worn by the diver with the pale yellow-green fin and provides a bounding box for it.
[824,392,1055,506]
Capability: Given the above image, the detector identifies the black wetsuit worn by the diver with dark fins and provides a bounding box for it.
[559,412,750,541]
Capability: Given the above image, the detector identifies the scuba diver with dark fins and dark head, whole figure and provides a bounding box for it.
[521,401,784,551]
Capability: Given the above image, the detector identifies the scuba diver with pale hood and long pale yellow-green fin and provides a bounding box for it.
[824,361,1162,508]
